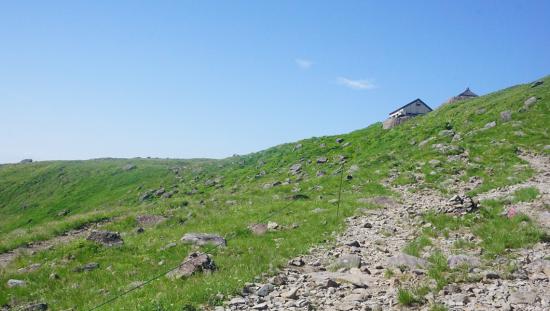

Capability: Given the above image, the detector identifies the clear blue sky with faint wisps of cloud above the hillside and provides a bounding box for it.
[0,0,550,162]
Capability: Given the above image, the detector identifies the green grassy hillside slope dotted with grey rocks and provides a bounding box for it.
[0,78,550,310]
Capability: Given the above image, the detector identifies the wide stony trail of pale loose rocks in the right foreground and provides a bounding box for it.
[220,155,550,311]
